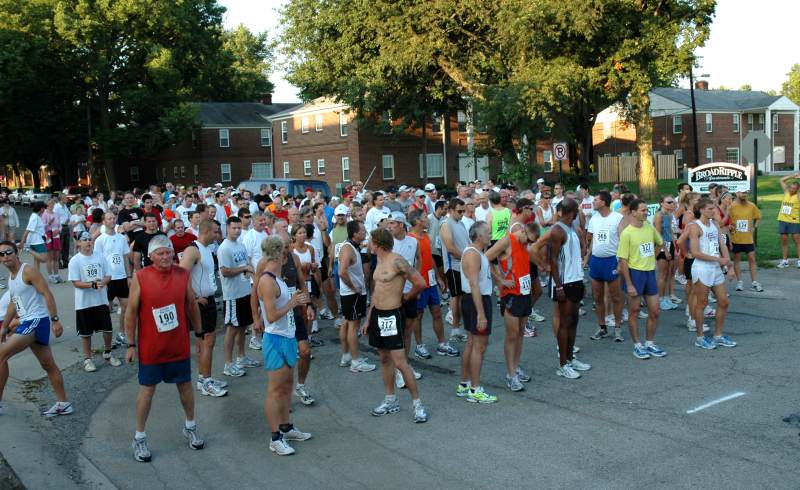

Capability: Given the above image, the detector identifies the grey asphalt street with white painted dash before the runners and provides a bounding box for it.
[0,205,800,489]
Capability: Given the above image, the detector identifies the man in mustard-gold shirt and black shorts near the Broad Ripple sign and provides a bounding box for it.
[730,192,764,293]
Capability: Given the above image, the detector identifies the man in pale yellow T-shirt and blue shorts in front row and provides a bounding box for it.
[617,199,667,359]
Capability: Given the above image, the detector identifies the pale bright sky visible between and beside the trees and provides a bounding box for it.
[220,0,800,102]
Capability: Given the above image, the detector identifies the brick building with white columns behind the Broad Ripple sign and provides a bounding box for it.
[592,82,800,172]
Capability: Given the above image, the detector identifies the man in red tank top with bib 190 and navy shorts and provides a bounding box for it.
[125,235,205,462]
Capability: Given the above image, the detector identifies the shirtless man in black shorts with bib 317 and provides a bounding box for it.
[361,228,428,423]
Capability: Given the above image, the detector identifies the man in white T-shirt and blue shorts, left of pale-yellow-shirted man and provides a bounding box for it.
[584,191,623,342]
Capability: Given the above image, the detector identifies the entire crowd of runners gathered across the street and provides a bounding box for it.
[0,174,800,461]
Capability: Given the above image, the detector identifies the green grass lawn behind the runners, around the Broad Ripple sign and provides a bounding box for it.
[592,176,795,267]
